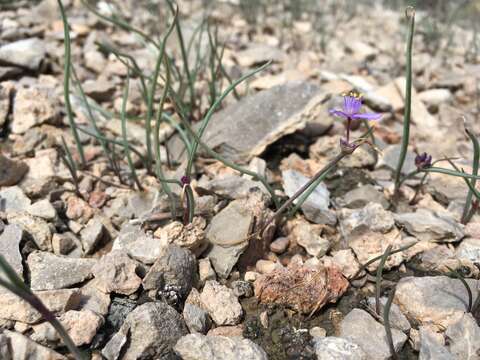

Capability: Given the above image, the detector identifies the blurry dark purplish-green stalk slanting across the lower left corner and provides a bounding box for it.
[0,255,85,360]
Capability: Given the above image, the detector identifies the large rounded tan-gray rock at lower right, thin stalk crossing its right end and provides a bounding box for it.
[395,276,479,327]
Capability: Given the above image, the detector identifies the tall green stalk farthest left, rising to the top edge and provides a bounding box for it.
[57,0,86,168]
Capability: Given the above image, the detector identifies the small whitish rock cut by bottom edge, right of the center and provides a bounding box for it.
[313,336,369,360]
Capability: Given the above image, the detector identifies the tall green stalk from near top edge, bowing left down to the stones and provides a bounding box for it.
[145,5,178,171]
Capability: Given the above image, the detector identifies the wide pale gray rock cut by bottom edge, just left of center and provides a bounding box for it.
[174,334,268,360]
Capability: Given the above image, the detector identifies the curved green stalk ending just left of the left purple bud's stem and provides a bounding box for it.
[153,57,177,218]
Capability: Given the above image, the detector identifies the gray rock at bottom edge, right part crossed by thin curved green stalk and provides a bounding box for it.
[340,309,407,360]
